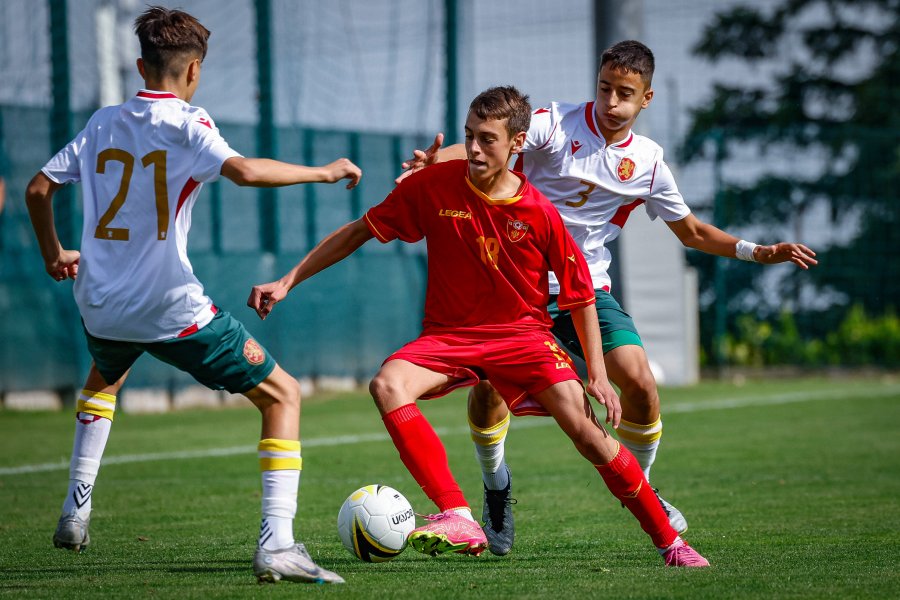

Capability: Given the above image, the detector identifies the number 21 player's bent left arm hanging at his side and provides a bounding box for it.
[25,172,81,281]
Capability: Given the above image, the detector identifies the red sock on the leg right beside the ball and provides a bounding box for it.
[382,404,469,512]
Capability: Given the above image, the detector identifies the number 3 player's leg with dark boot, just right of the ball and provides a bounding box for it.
[468,381,515,556]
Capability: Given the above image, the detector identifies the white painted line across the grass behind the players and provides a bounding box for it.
[0,384,900,476]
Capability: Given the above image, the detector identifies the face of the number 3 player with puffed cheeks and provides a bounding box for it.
[594,64,653,138]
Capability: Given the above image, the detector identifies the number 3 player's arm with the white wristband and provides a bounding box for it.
[666,214,819,269]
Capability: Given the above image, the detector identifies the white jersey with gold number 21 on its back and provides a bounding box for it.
[42,90,240,342]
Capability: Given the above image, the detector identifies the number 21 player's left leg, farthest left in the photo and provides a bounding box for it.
[53,363,127,552]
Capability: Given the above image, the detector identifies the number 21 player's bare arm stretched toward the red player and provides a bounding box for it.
[222,156,362,190]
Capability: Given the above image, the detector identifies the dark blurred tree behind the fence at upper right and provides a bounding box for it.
[681,0,900,364]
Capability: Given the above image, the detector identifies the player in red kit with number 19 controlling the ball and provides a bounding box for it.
[248,87,709,566]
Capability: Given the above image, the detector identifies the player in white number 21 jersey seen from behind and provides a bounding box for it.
[26,7,361,583]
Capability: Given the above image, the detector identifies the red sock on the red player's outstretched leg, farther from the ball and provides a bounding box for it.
[594,444,678,548]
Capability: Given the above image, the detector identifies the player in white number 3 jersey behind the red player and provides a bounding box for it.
[398,41,816,555]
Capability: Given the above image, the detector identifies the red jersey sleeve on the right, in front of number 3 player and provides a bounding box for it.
[545,206,596,310]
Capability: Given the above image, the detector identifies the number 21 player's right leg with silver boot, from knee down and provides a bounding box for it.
[244,365,344,583]
